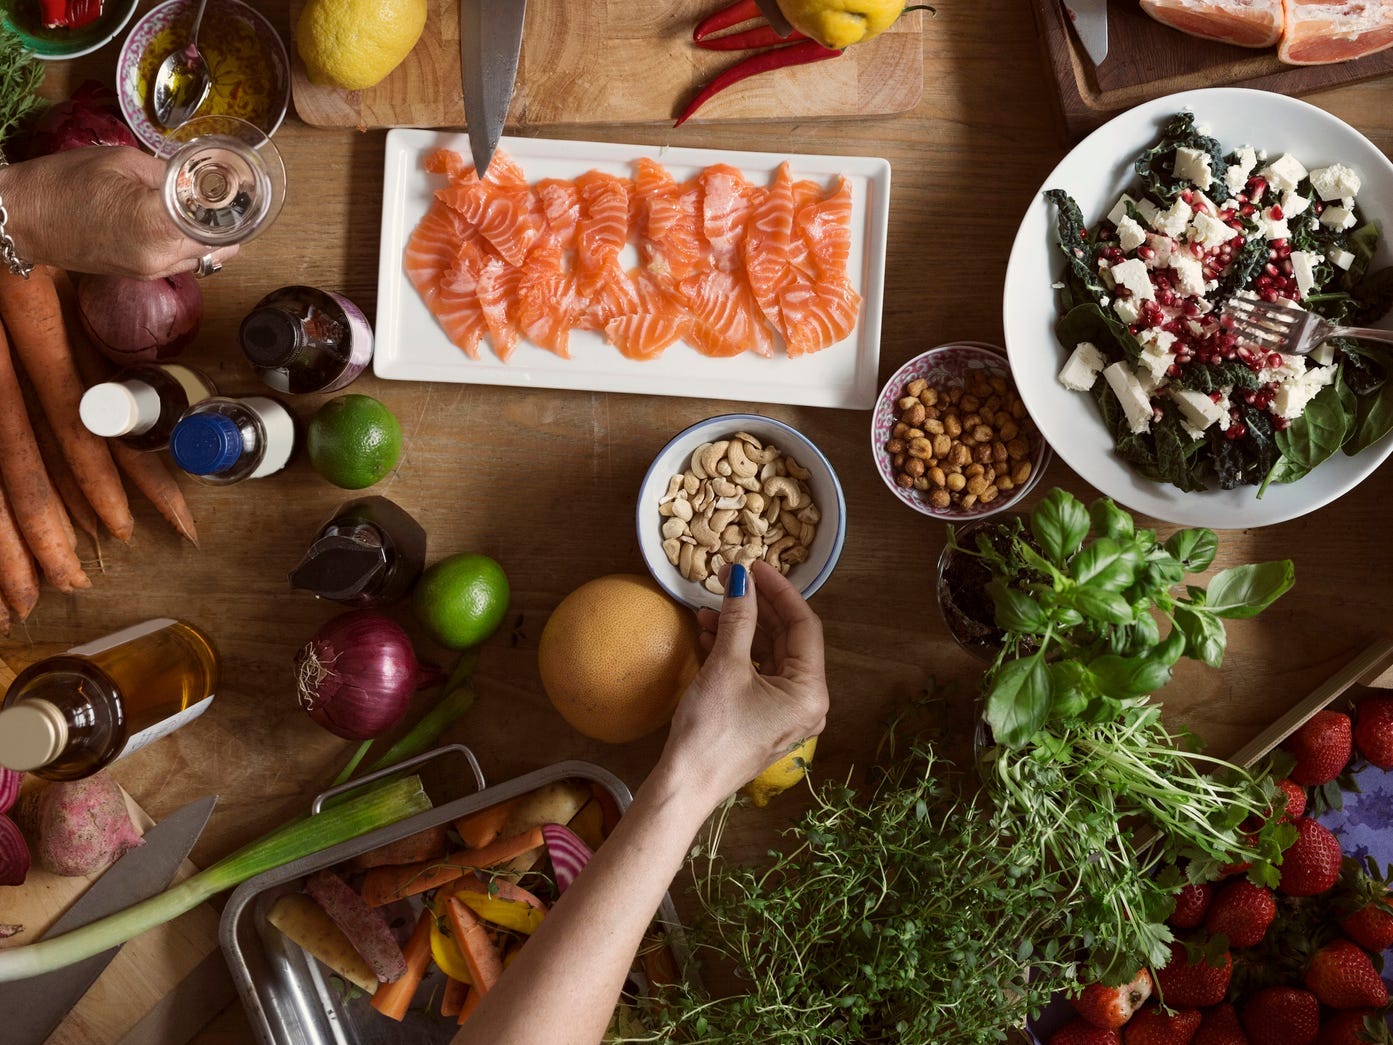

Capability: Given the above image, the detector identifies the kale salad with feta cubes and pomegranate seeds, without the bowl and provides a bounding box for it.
[1045,113,1393,496]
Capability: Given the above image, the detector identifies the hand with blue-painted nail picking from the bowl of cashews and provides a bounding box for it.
[663,563,827,805]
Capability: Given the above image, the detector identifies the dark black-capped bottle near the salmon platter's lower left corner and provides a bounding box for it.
[238,286,372,394]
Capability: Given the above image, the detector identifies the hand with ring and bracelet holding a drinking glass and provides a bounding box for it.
[0,145,237,279]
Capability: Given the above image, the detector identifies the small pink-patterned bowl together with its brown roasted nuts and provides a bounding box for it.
[871,341,1049,523]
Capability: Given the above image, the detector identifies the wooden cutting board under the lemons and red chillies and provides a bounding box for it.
[290,0,924,128]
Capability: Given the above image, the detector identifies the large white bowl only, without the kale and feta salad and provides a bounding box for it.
[1003,88,1393,529]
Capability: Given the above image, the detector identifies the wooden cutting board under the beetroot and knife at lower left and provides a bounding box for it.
[0,662,217,1045]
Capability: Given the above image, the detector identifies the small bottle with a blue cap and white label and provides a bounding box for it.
[170,396,295,486]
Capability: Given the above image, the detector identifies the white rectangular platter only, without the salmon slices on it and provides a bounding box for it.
[373,128,890,410]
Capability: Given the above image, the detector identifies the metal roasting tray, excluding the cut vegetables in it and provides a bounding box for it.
[219,744,687,1045]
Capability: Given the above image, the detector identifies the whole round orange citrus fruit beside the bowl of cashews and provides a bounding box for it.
[536,574,701,744]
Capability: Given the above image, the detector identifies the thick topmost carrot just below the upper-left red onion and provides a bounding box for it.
[0,266,135,541]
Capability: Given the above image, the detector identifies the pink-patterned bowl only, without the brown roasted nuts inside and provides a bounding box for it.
[871,341,1049,523]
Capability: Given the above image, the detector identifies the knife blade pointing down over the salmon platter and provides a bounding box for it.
[460,0,527,178]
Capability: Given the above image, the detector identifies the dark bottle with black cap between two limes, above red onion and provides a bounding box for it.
[290,497,426,607]
